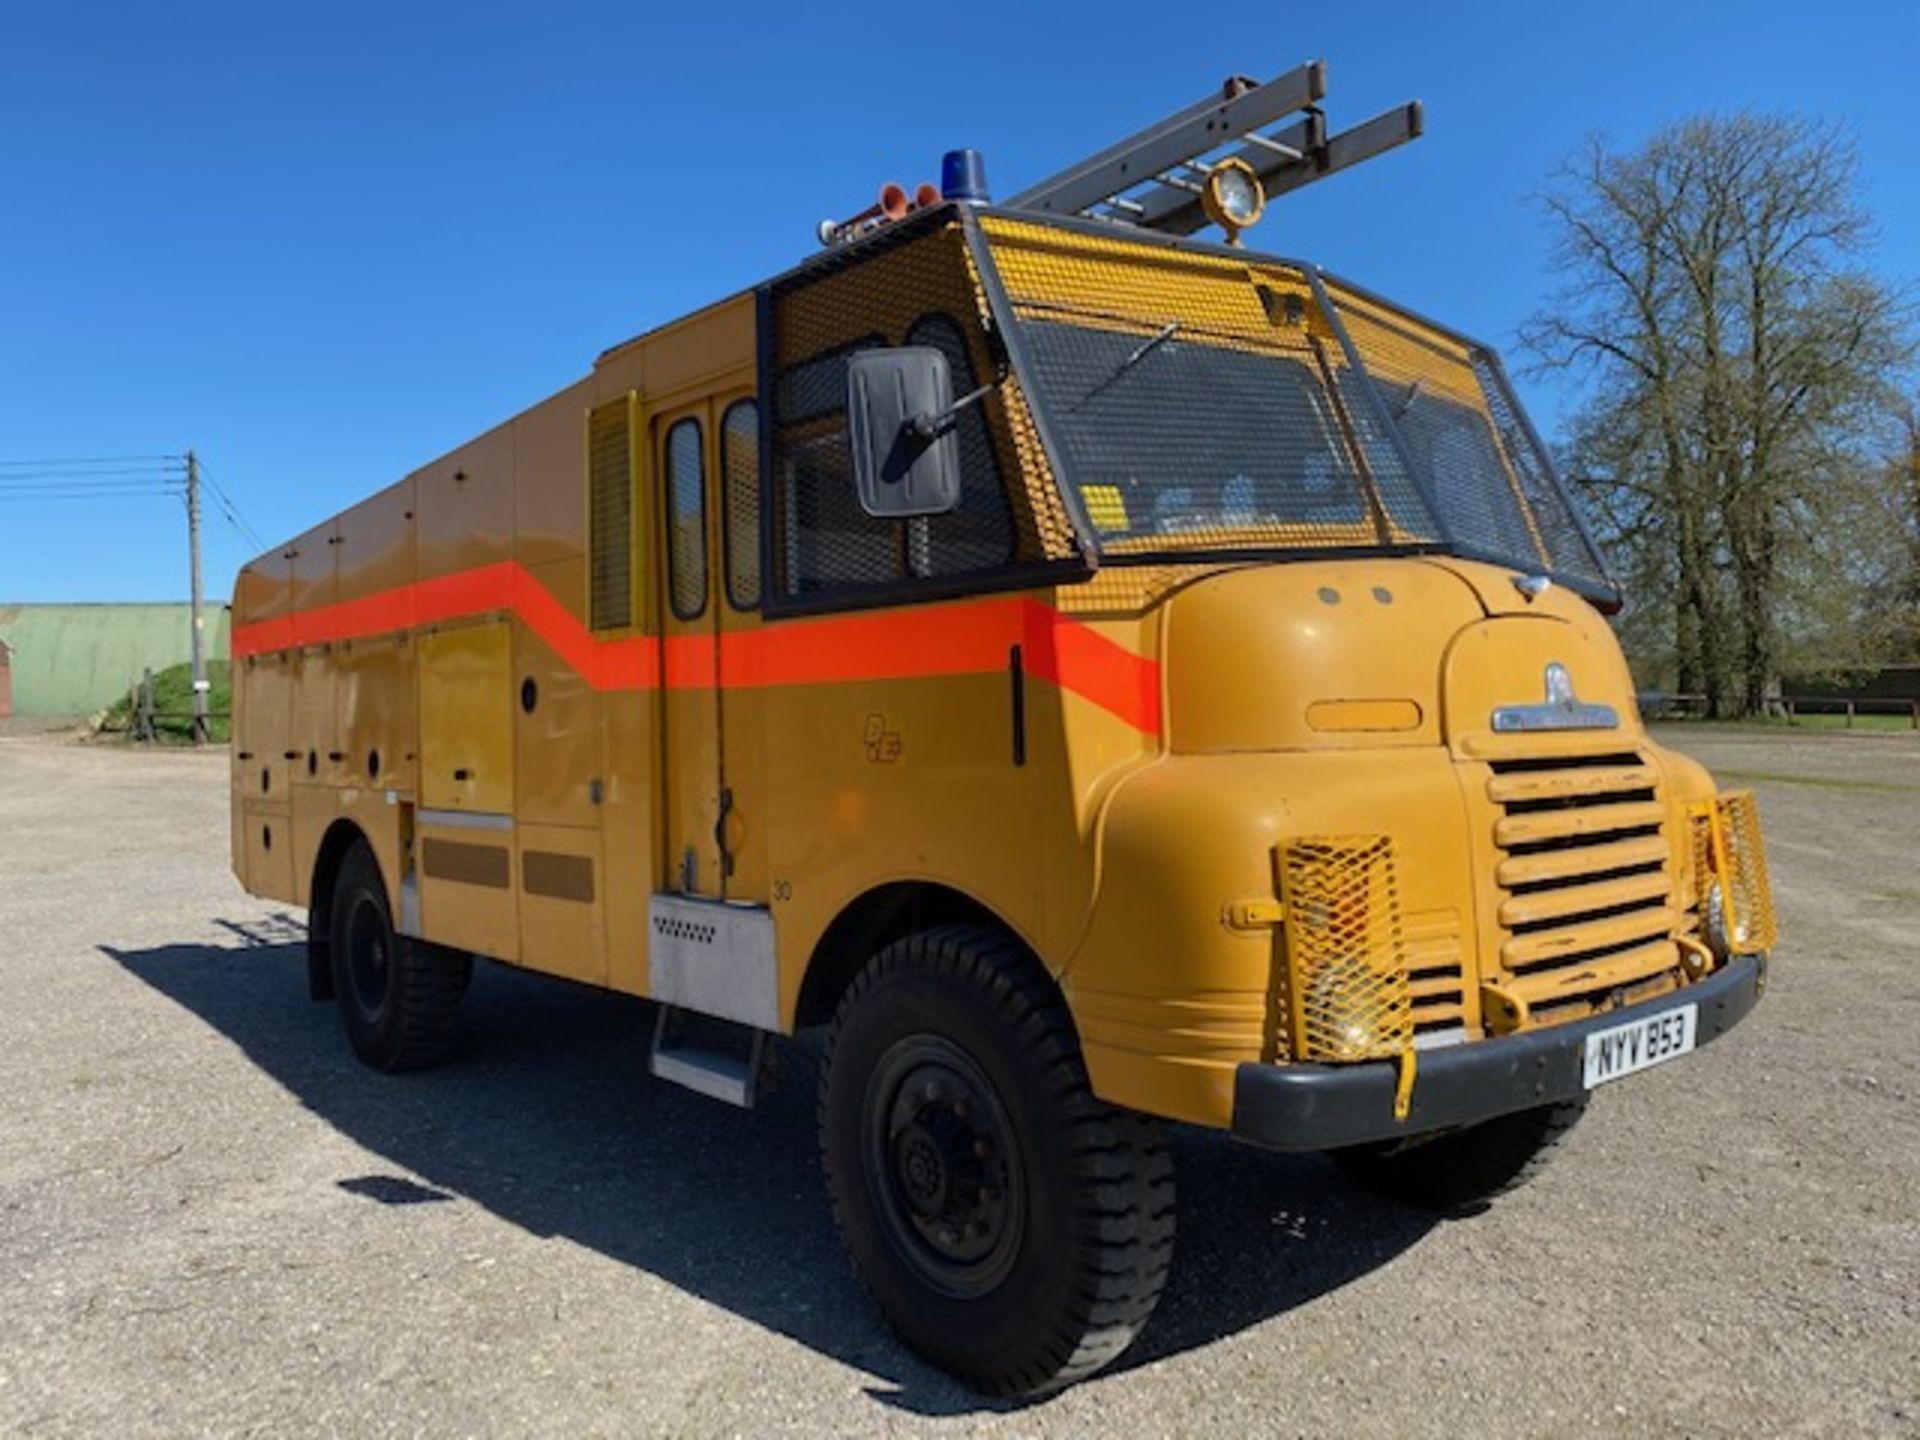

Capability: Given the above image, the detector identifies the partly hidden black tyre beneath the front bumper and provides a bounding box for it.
[1327,1100,1586,1210]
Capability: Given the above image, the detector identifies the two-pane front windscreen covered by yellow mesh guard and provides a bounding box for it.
[981,215,1617,601]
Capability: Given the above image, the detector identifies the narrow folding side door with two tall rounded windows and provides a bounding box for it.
[653,386,766,900]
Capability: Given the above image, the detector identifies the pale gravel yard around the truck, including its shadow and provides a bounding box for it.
[0,728,1920,1436]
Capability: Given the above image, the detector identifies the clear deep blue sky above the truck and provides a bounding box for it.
[0,0,1920,601]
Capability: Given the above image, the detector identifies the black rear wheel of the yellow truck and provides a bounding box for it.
[328,841,472,1069]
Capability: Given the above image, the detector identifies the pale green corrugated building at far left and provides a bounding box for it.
[0,601,230,716]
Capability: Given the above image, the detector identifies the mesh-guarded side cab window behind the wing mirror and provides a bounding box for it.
[764,213,1079,601]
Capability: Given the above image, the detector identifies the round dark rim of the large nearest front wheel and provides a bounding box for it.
[862,1035,1025,1298]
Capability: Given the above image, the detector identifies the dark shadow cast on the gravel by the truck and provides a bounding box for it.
[102,922,1436,1415]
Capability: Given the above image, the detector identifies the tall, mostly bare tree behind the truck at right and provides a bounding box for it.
[1523,115,1920,714]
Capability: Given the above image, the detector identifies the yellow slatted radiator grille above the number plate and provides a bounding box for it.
[1488,755,1682,1023]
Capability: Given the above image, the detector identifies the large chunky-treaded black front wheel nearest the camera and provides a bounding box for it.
[820,927,1173,1396]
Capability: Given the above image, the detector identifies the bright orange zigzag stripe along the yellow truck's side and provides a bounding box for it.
[232,561,1162,735]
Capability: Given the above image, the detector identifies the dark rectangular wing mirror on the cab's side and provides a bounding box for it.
[847,346,972,520]
